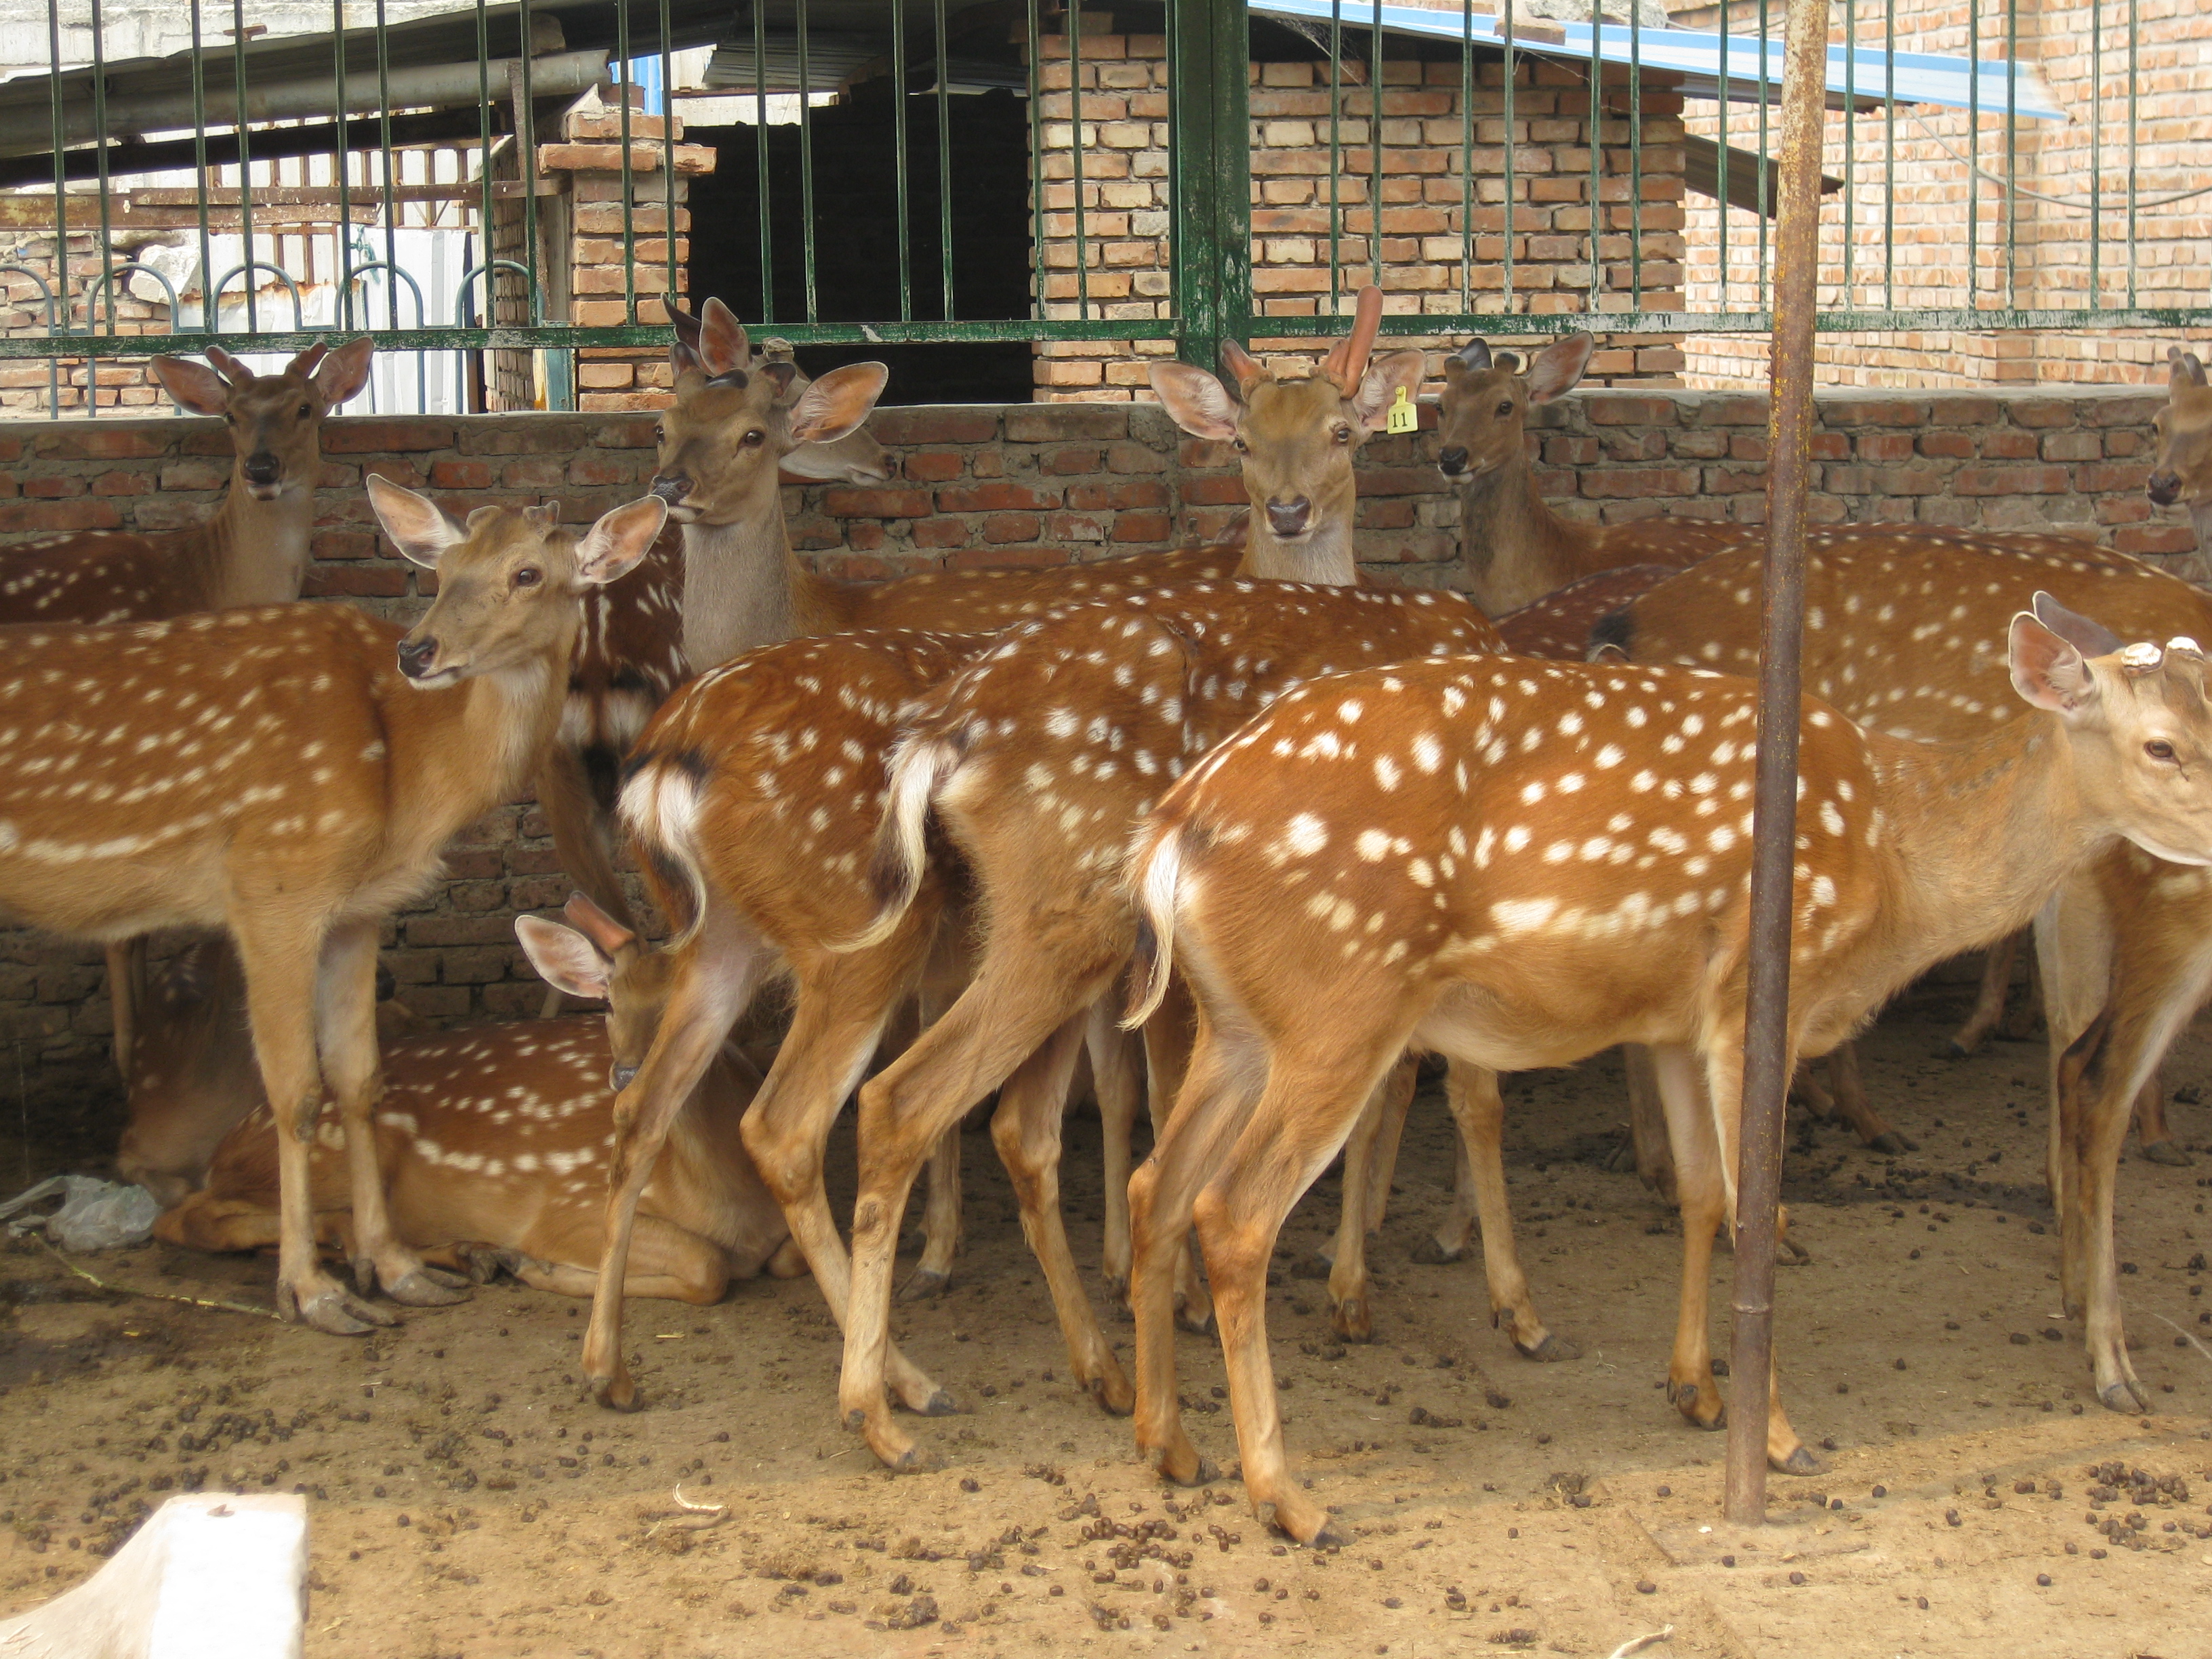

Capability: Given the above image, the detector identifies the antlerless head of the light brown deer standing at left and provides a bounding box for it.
[369,473,668,690]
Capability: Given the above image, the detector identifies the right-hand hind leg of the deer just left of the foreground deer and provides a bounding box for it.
[991,1013,1137,1416]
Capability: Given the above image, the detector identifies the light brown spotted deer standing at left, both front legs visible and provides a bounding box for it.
[0,478,663,1334]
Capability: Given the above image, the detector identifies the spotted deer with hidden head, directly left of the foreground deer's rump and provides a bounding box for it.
[838,581,1498,1467]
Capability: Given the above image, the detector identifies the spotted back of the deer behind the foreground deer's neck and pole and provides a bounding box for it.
[1595,527,2212,739]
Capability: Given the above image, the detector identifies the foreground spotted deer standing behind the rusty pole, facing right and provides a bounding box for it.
[1130,595,2212,1542]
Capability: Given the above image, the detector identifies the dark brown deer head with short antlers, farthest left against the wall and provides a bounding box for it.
[152,338,374,502]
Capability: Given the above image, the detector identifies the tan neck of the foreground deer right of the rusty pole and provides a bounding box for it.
[1869,714,2114,973]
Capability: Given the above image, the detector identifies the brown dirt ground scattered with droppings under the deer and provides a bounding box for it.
[0,996,2212,1659]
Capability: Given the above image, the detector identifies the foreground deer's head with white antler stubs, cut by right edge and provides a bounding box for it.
[2009,593,2212,865]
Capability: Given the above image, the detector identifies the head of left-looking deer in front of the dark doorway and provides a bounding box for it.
[653,299,889,525]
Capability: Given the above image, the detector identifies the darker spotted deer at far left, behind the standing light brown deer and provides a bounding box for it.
[0,338,371,1078]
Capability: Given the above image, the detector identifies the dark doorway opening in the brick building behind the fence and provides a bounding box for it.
[688,80,1036,405]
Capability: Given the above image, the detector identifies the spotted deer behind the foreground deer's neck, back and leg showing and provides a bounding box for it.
[1606,527,2212,1409]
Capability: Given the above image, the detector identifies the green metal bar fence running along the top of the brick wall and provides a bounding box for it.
[0,0,2212,403]
